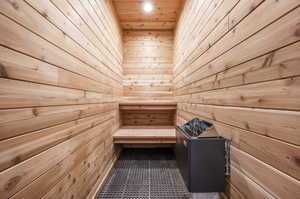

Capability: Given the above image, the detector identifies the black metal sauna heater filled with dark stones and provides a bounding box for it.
[175,118,229,193]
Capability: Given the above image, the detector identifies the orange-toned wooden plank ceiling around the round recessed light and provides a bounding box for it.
[113,0,184,30]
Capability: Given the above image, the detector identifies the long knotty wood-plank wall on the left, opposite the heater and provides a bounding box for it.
[0,0,122,199]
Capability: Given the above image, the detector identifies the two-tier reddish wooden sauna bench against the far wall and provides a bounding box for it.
[113,101,177,146]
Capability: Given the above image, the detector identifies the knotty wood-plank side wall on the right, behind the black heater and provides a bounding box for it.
[174,0,300,199]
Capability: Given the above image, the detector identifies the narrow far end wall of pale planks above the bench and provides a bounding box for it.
[123,31,173,100]
